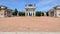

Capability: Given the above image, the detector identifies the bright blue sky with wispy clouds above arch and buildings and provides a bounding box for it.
[0,0,60,11]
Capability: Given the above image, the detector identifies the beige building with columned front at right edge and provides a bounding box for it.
[49,6,60,17]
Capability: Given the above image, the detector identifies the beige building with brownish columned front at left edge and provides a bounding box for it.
[0,5,13,17]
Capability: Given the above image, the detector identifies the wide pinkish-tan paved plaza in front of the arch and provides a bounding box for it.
[0,17,60,32]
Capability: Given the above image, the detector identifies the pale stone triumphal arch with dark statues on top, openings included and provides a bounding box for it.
[25,4,36,16]
